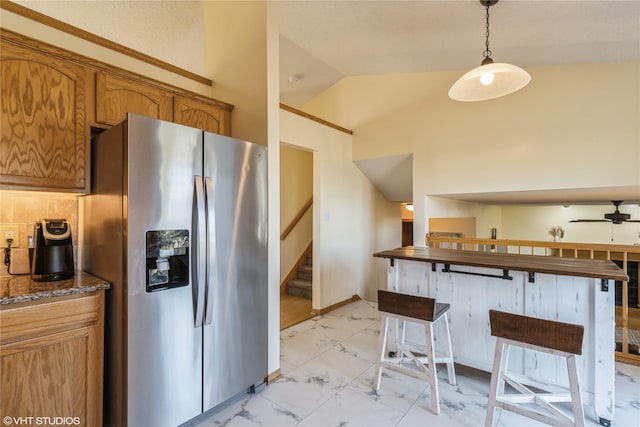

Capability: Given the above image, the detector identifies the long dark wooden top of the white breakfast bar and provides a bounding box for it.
[373,246,629,281]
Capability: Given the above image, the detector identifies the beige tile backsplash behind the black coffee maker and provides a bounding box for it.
[0,190,79,276]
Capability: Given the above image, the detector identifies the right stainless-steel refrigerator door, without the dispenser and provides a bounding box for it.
[203,133,267,411]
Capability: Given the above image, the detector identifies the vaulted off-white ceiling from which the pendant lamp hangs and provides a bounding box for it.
[278,0,640,107]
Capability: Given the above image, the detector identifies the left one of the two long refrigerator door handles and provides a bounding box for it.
[193,175,207,328]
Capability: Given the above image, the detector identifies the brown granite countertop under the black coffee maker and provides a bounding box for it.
[0,271,110,305]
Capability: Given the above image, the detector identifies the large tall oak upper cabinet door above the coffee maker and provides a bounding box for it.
[0,43,89,192]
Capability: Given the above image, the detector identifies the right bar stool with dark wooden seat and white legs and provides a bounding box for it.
[485,310,585,427]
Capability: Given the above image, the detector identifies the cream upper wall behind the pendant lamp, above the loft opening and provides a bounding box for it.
[303,62,640,246]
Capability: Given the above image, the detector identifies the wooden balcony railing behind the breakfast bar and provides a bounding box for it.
[425,235,640,364]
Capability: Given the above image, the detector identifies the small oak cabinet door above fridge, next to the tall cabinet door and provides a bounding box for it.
[96,72,173,125]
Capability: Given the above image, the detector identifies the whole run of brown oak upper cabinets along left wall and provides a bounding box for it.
[0,28,233,193]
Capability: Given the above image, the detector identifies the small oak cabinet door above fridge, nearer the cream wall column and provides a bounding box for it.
[173,96,231,136]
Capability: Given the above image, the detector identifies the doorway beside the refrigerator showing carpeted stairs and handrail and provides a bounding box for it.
[280,144,314,330]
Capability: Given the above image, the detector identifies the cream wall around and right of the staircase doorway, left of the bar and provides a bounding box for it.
[280,110,402,309]
